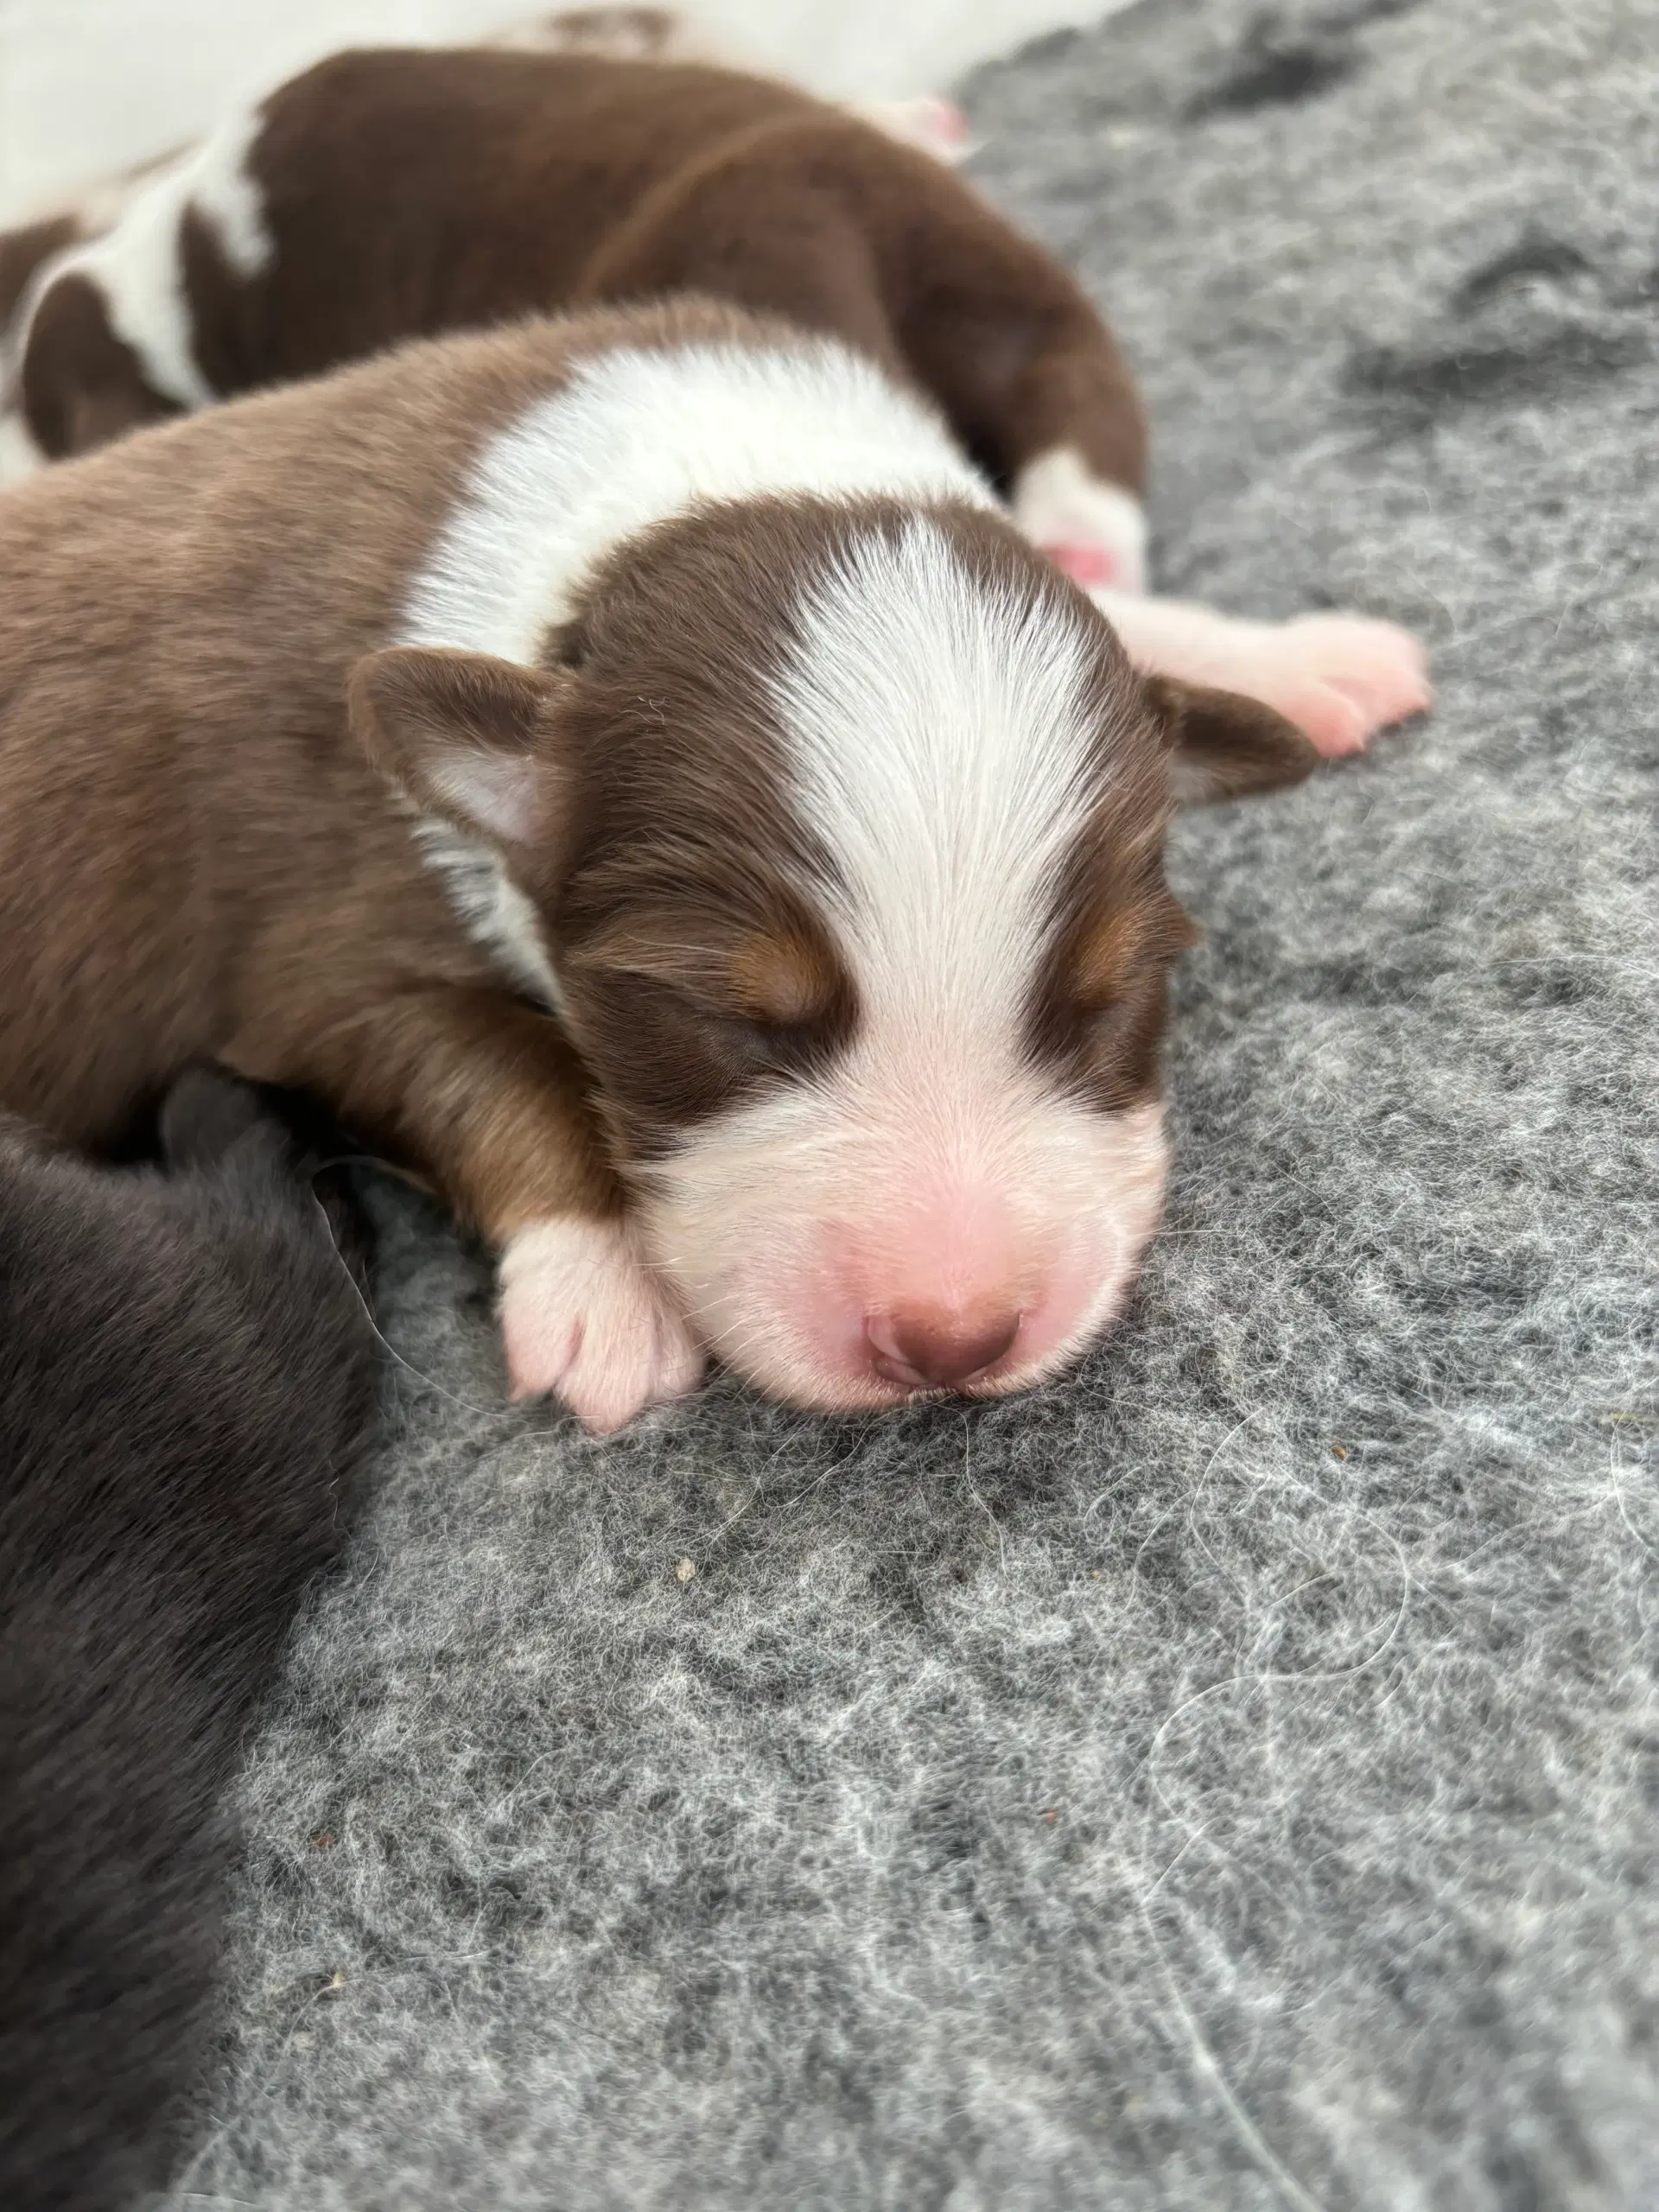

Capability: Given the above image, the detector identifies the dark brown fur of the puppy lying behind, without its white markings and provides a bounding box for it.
[13,48,1146,493]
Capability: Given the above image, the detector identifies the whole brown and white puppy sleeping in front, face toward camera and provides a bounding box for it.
[0,303,1316,1427]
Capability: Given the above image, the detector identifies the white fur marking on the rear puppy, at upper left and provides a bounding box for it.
[16,108,274,407]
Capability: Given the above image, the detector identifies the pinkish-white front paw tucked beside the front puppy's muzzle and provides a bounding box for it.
[500,1214,703,1435]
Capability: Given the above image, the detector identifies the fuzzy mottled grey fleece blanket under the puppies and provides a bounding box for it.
[159,0,1659,2212]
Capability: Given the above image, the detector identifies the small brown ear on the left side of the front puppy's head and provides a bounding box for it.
[347,646,570,845]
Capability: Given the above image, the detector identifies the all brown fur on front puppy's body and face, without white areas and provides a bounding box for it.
[0,303,1300,1292]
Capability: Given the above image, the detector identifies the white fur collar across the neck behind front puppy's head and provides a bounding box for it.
[403,339,995,661]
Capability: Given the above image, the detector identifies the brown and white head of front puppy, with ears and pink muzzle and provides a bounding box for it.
[354,500,1312,1407]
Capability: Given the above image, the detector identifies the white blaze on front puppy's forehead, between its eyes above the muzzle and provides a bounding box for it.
[777,515,1090,1035]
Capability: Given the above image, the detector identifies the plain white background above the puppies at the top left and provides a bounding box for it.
[0,0,1123,219]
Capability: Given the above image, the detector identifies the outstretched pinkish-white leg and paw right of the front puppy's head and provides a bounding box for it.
[1093,591,1431,757]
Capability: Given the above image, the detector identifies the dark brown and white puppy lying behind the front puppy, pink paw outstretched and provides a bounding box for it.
[0,23,1427,754]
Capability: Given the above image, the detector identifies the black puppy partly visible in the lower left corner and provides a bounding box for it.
[0,1073,374,2212]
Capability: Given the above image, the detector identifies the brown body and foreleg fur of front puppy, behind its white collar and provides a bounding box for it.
[0,311,611,1236]
